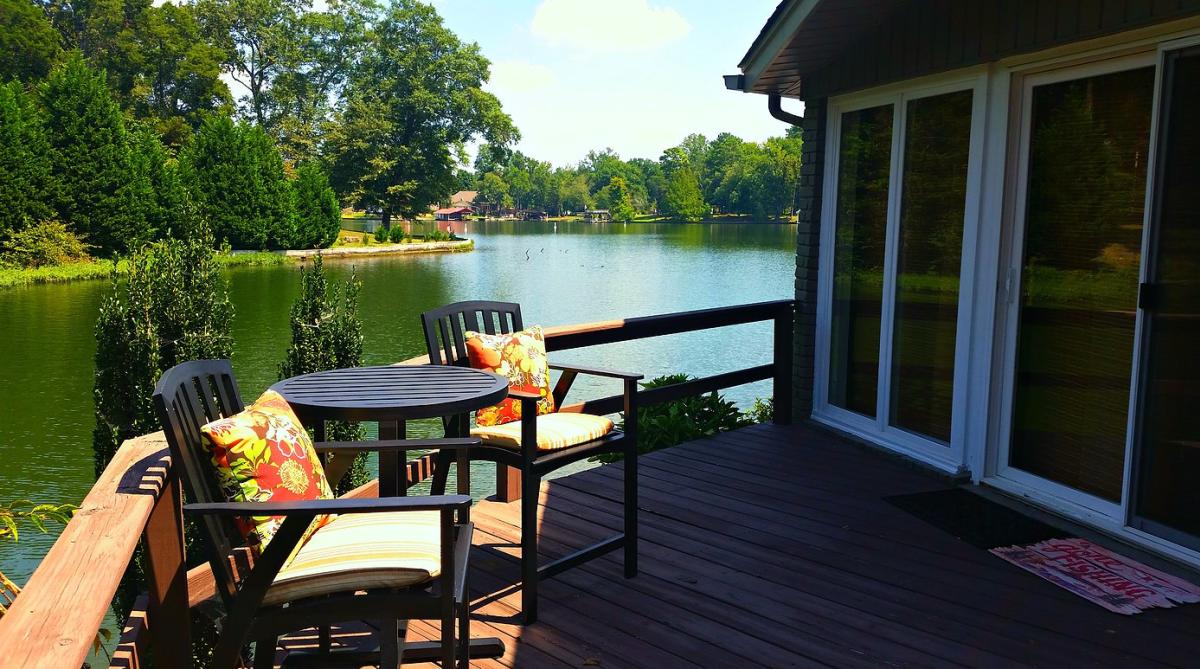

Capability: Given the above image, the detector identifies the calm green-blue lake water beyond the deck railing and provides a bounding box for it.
[0,222,796,583]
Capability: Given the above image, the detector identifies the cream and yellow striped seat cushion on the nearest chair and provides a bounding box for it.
[263,511,442,605]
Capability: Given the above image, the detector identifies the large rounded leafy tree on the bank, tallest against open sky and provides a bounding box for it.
[326,0,517,227]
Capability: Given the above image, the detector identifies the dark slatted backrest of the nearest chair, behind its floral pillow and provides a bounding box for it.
[154,360,245,607]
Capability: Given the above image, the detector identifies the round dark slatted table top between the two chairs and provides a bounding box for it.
[271,364,509,421]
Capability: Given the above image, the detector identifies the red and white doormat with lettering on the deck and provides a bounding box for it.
[991,538,1200,615]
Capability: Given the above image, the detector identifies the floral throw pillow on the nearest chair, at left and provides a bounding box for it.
[200,391,334,550]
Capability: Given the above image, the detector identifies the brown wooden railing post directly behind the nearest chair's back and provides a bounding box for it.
[142,471,192,669]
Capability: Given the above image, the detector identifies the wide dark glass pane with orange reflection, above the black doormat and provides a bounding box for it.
[1008,67,1154,501]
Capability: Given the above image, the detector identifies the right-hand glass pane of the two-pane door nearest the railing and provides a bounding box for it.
[889,90,972,442]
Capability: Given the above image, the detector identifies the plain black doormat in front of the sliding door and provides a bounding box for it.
[883,488,1067,550]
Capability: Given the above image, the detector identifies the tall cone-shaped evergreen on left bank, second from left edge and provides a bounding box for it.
[41,52,151,254]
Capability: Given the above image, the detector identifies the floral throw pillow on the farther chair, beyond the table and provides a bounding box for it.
[466,326,554,427]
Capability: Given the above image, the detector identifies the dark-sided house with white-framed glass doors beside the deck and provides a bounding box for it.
[726,0,1200,566]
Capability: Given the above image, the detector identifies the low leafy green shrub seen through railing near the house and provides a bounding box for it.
[593,374,750,463]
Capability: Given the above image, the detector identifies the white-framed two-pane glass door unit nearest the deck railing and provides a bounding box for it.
[818,79,977,465]
